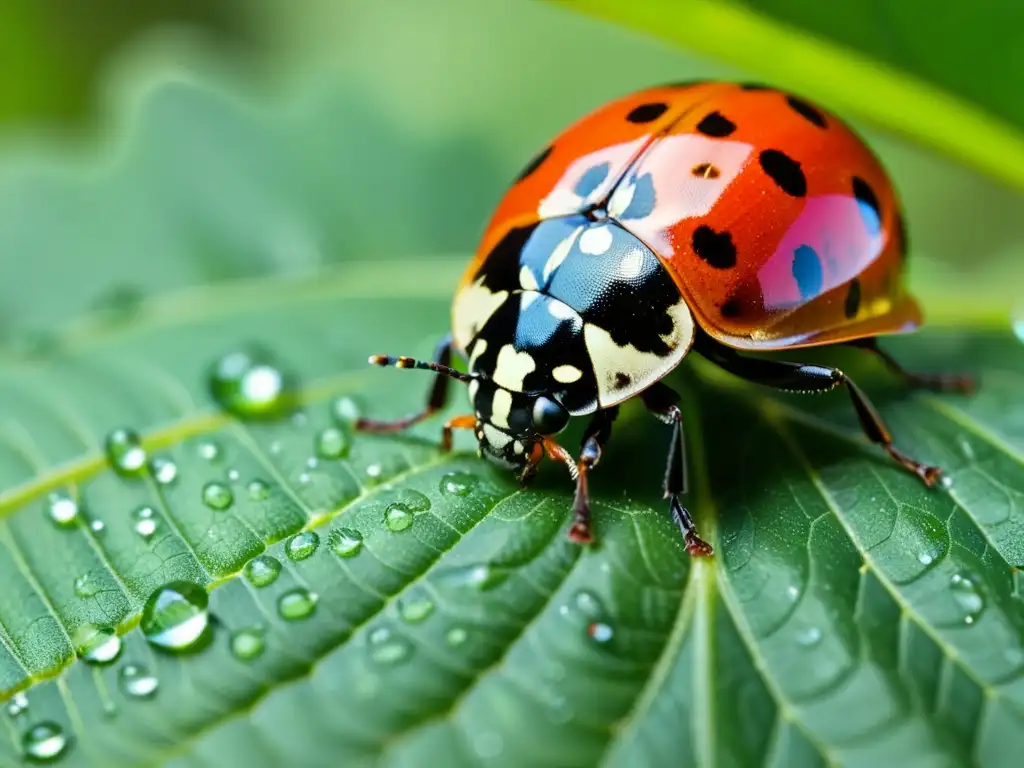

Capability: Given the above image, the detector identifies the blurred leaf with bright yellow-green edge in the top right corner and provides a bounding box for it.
[549,0,1024,186]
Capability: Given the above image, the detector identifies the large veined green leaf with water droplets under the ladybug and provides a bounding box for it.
[0,24,1024,766]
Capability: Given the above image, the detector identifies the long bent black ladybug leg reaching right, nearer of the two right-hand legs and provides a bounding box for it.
[697,339,942,487]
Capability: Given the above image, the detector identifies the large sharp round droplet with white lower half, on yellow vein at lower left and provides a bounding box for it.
[140,581,210,653]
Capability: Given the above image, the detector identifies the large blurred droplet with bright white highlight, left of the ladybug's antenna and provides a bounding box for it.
[209,348,296,418]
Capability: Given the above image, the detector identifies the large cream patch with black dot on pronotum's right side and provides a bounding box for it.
[584,299,693,408]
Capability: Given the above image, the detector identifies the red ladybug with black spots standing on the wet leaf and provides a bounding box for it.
[356,82,973,556]
